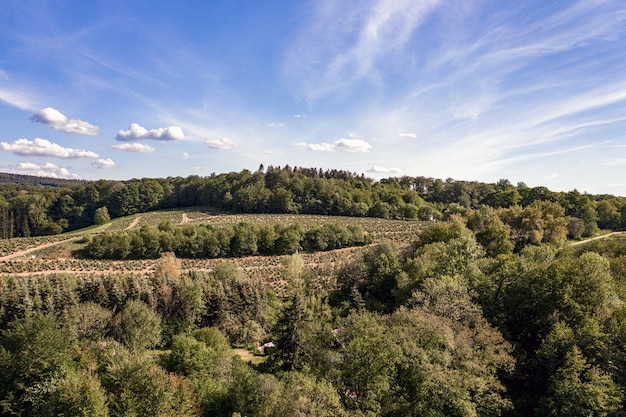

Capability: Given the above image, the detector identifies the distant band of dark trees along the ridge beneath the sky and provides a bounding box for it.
[0,166,626,238]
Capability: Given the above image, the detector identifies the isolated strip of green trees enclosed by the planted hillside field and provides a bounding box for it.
[83,221,372,259]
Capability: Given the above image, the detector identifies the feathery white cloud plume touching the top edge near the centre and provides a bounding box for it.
[285,0,441,98]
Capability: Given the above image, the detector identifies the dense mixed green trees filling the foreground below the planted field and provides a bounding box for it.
[0,219,626,417]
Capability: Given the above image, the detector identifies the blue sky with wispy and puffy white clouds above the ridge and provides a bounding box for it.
[0,0,626,196]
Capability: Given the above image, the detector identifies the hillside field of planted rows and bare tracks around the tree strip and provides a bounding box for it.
[0,209,428,293]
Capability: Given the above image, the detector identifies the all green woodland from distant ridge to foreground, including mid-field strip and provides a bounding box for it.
[0,167,626,417]
